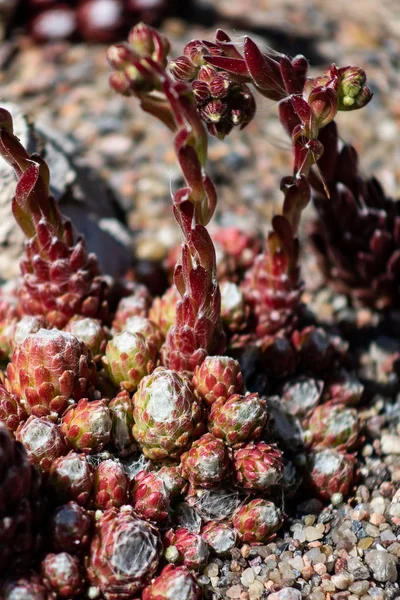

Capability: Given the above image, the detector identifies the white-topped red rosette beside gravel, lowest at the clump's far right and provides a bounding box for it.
[308,449,355,500]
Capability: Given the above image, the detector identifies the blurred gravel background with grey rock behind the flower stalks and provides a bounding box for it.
[0,0,400,284]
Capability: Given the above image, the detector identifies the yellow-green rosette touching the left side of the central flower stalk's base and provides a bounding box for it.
[103,331,157,392]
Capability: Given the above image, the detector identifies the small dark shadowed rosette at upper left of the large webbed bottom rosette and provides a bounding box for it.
[48,500,92,554]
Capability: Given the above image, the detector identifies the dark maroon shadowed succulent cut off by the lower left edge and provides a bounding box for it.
[0,425,42,573]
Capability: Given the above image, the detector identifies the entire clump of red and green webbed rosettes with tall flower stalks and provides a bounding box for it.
[0,18,399,600]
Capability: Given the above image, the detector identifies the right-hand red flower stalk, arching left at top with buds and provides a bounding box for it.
[177,30,372,339]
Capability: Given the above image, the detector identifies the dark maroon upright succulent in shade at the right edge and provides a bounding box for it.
[312,122,400,309]
